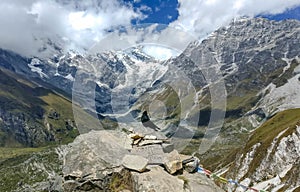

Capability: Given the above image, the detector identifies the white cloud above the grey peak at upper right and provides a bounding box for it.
[171,0,300,38]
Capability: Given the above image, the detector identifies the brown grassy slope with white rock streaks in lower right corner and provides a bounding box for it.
[227,109,300,191]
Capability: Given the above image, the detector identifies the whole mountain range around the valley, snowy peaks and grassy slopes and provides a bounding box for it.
[0,18,300,191]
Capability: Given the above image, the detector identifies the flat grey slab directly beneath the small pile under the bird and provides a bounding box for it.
[130,145,165,164]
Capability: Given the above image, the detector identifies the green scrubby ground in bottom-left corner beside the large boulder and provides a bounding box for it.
[0,148,62,192]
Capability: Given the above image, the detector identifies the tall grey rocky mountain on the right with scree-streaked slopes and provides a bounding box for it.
[131,18,300,136]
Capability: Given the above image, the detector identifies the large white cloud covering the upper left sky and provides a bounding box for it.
[0,0,143,56]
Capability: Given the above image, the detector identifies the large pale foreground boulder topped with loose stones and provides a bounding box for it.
[63,130,222,192]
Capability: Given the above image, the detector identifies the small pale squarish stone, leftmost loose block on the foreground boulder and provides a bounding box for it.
[122,155,148,172]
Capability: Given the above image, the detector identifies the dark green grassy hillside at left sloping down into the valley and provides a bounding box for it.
[0,69,97,148]
